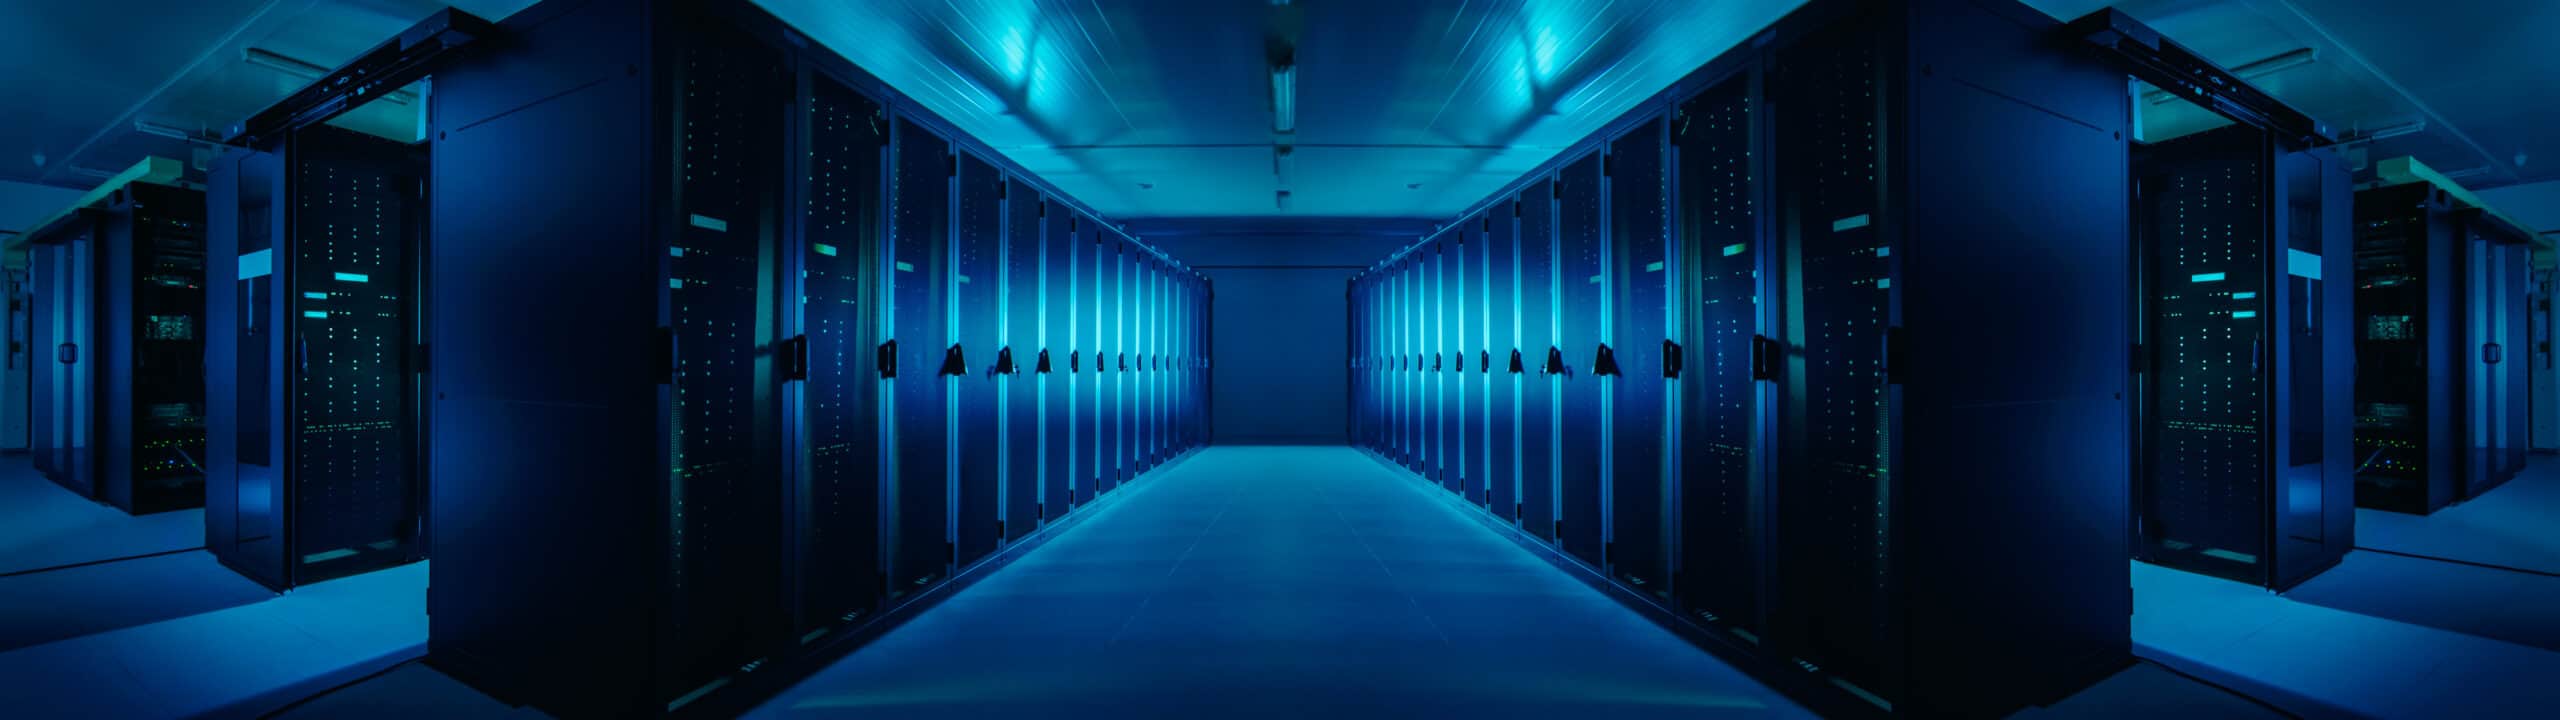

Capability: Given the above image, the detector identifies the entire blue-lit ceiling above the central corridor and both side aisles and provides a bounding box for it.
[0,0,2560,218]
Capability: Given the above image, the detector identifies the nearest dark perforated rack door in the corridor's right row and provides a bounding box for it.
[1769,23,1904,700]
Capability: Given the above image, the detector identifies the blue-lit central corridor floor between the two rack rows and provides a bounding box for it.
[750,446,1810,720]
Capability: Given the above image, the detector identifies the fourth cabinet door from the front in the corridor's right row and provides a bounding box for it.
[1554,154,1618,569]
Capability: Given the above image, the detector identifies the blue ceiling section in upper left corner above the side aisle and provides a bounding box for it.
[0,0,532,187]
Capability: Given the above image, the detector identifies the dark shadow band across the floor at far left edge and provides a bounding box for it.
[0,551,274,651]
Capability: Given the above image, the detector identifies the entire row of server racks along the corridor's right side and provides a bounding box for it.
[1349,3,2132,715]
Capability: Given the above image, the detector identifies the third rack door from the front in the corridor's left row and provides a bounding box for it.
[888,115,952,589]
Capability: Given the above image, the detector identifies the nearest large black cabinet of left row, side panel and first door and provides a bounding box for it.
[428,3,788,717]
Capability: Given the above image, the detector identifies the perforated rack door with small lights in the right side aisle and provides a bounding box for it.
[2140,131,2276,582]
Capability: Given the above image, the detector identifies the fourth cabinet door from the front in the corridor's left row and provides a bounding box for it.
[945,151,1006,566]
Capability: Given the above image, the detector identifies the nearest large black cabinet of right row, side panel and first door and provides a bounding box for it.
[1764,0,2132,715]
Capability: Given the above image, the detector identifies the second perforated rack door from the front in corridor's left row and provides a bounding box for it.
[796,74,888,633]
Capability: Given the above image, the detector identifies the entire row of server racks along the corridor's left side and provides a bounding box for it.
[428,0,1208,717]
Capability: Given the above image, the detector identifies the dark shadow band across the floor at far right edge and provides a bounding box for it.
[2286,551,2560,651]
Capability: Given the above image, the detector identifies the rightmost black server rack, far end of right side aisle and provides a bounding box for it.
[2355,182,2529,512]
